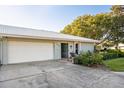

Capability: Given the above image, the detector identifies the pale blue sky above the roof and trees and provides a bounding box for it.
[0,5,111,32]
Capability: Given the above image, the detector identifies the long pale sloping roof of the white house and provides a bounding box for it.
[0,25,99,43]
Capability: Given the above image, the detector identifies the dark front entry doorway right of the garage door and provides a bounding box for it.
[61,43,68,58]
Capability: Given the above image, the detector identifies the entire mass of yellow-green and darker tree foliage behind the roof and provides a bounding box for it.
[61,5,124,48]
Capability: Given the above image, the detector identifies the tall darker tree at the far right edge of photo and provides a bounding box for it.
[107,5,124,49]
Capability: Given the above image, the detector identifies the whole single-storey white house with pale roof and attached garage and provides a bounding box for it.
[0,25,99,64]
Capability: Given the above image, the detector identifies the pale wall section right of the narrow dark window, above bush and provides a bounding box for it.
[81,43,94,52]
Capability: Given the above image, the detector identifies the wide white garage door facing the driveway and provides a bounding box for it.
[8,41,53,64]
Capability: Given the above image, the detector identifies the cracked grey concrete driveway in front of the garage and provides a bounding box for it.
[0,60,124,88]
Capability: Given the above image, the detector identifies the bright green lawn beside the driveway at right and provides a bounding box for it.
[104,58,124,71]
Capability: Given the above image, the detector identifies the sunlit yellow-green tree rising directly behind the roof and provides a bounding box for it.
[61,14,105,39]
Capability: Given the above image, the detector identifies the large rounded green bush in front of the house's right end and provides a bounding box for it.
[74,52,103,66]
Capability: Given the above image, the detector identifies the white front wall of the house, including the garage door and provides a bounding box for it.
[1,38,94,64]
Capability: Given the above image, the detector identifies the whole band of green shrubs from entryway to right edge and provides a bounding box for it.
[74,50,124,66]
